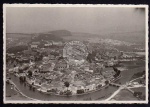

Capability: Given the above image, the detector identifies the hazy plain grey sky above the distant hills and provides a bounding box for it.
[6,7,145,34]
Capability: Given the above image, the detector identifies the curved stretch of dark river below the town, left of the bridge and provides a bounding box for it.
[7,75,117,101]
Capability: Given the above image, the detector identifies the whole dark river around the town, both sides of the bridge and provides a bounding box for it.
[7,67,144,101]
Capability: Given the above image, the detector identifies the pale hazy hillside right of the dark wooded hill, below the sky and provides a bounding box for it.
[64,32,145,45]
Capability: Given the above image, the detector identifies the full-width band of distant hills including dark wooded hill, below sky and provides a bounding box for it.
[6,30,145,46]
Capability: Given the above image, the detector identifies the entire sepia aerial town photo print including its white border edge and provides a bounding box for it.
[3,4,148,103]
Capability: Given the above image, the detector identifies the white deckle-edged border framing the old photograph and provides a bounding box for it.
[3,4,149,104]
